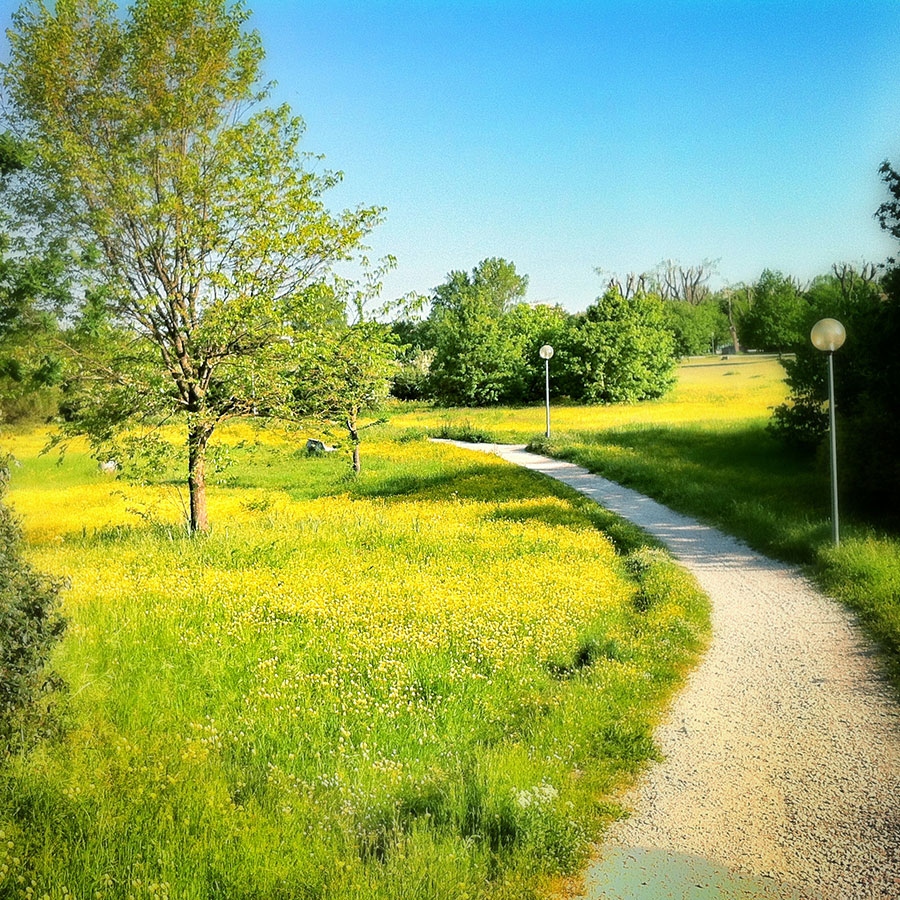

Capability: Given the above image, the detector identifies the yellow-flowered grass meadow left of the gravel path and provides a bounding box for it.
[0,427,708,900]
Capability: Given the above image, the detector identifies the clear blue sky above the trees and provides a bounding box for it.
[0,0,900,309]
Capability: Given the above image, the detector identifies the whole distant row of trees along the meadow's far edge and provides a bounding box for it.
[393,257,883,406]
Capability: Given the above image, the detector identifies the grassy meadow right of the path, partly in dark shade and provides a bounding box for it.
[394,356,900,689]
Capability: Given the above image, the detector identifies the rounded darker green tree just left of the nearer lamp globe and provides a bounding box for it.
[738,269,808,352]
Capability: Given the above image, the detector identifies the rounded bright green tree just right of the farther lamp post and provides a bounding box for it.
[560,288,676,403]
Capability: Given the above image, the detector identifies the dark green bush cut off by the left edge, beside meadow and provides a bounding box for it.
[0,472,65,753]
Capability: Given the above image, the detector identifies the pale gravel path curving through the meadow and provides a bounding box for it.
[442,443,900,900]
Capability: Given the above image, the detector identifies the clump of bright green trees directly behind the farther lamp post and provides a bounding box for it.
[422,272,675,406]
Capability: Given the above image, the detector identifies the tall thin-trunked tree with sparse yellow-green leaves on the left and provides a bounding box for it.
[2,0,381,531]
